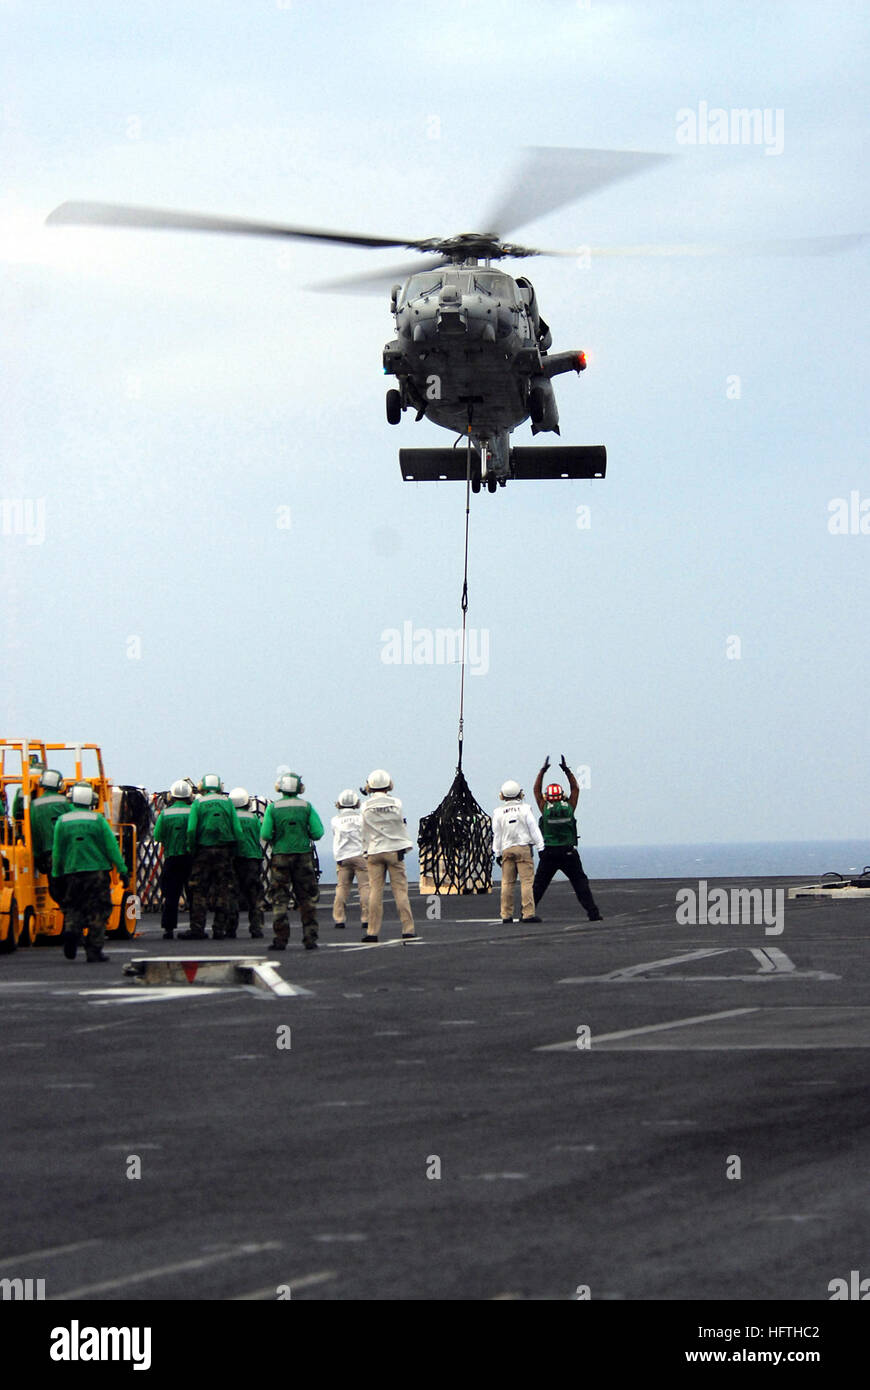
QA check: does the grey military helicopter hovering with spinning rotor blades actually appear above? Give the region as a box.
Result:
[46,147,866,492]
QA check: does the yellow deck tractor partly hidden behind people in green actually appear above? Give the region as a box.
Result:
[0,738,139,955]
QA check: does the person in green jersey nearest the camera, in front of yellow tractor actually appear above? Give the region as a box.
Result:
[51,783,129,960]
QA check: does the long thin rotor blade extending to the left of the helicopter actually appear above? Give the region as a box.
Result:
[46,203,428,249]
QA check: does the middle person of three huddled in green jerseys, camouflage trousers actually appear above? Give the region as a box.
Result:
[178,773,243,941]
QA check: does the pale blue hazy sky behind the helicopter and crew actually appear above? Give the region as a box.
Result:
[0,0,870,845]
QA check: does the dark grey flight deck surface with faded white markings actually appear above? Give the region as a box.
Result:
[0,880,870,1321]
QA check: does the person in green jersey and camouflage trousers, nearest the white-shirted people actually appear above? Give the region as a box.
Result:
[263,773,324,951]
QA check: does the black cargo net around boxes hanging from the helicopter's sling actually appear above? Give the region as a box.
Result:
[417,770,492,894]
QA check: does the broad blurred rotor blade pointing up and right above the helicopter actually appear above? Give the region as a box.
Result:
[482,146,675,236]
